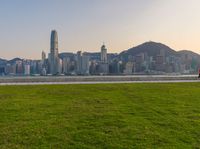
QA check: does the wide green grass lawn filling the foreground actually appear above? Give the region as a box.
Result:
[0,83,200,149]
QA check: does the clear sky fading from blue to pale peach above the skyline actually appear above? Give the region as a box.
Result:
[0,0,200,59]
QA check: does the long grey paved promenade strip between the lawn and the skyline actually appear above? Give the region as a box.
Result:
[0,75,200,85]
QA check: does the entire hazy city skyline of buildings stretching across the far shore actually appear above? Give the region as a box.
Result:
[0,30,199,76]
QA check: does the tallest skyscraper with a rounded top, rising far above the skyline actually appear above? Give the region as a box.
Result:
[49,30,60,75]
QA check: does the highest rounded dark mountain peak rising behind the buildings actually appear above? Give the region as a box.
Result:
[119,41,177,60]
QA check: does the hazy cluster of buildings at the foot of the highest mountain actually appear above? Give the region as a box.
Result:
[123,50,200,74]
